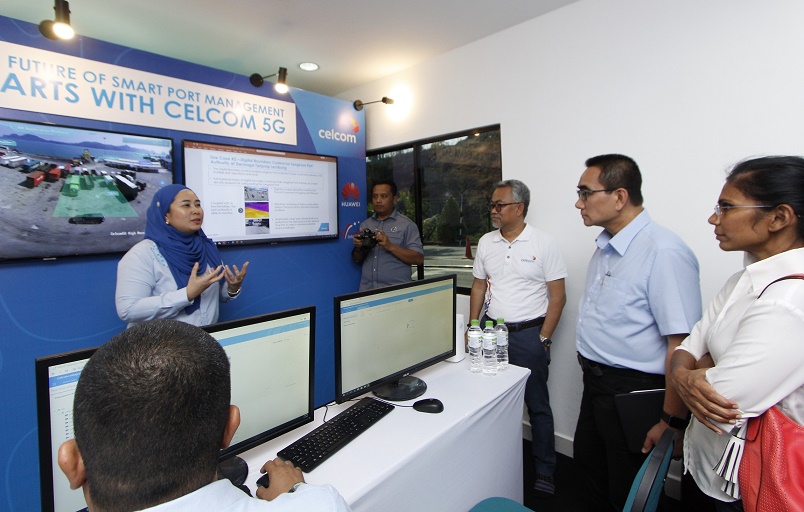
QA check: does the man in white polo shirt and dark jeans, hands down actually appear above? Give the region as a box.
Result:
[469,180,567,496]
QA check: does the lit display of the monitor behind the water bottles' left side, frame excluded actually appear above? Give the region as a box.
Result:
[341,283,455,390]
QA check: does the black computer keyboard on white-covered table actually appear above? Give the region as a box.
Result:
[277,397,394,473]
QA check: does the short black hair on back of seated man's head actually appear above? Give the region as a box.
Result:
[73,320,231,510]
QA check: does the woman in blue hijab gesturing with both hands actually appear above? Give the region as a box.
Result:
[115,185,248,326]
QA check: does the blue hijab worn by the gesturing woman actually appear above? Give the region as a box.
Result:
[145,185,221,314]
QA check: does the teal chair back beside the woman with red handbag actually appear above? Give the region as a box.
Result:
[623,428,676,512]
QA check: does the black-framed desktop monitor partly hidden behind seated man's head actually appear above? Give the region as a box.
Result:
[36,306,315,512]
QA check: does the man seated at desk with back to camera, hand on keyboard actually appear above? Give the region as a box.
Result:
[59,320,349,512]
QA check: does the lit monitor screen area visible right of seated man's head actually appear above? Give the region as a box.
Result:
[212,314,310,445]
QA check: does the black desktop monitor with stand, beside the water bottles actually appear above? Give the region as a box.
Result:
[335,274,457,403]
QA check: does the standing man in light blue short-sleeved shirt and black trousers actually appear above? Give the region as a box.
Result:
[573,154,701,511]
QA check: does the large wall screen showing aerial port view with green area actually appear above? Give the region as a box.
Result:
[0,119,173,260]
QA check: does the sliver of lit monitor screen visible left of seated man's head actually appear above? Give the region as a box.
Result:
[48,359,89,512]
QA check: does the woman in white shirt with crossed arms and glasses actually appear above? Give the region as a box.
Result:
[670,156,804,511]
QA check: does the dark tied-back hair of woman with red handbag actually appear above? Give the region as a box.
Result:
[726,156,804,238]
